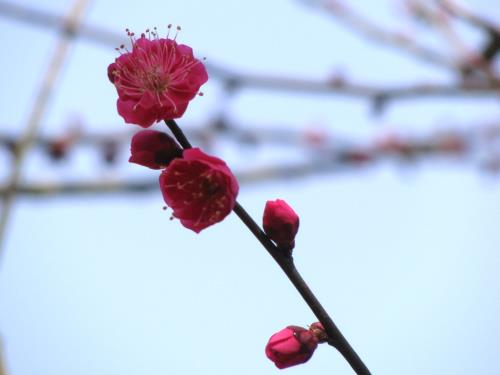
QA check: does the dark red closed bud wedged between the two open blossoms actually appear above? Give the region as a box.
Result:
[128,130,182,169]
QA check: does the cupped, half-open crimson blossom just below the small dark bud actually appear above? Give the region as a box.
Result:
[160,148,239,233]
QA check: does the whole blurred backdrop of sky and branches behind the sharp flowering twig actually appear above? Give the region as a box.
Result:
[0,0,500,375]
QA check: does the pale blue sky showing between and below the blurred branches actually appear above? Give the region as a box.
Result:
[0,0,500,375]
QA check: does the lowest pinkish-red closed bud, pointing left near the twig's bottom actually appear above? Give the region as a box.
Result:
[266,326,318,369]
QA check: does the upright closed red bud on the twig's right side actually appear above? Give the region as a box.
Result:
[263,199,299,251]
